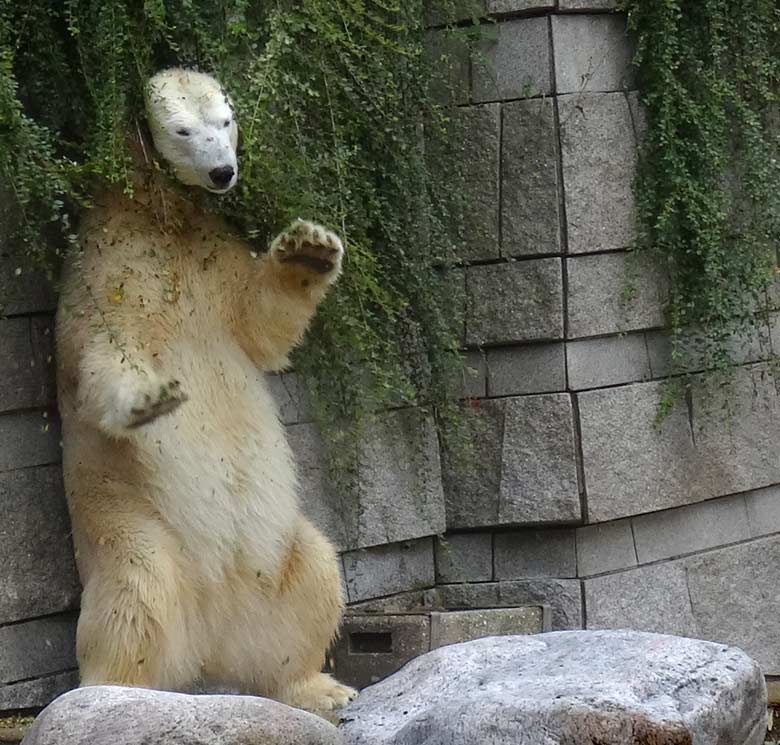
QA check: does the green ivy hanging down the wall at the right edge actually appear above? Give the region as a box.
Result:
[624,0,780,406]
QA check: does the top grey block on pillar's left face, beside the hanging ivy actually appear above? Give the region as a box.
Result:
[471,18,552,103]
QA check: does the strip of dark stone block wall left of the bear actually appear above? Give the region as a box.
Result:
[0,224,80,710]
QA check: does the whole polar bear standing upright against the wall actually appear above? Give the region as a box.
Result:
[57,69,355,711]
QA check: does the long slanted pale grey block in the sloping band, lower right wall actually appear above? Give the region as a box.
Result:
[632,494,750,564]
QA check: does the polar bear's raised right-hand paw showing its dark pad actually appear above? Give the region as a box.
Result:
[269,220,344,290]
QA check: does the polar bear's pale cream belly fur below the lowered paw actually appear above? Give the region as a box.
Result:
[132,336,298,581]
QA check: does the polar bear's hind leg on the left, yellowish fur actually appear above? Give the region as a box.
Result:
[77,508,199,690]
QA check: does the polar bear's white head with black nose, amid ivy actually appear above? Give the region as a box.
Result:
[146,68,238,194]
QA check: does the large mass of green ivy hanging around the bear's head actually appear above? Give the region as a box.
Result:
[0,0,472,470]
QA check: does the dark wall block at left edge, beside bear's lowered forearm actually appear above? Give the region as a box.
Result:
[0,318,55,411]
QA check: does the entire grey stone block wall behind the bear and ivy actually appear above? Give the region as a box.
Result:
[0,0,780,709]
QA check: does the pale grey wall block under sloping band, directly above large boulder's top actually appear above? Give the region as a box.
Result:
[584,562,700,636]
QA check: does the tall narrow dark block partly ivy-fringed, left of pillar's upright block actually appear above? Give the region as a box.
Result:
[450,104,501,261]
